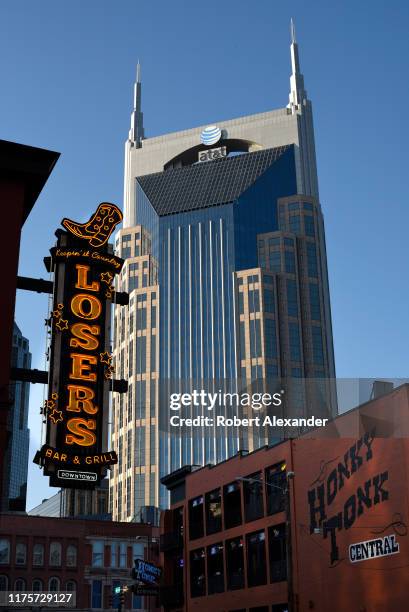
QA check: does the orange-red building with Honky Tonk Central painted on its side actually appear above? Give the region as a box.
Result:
[161,385,409,612]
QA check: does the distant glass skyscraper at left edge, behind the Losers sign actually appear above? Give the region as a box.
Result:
[1,323,31,512]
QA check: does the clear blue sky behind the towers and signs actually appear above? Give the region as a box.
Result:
[0,0,409,508]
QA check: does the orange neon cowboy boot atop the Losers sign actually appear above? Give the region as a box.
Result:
[61,202,122,247]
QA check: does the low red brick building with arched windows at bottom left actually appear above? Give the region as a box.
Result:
[0,514,159,610]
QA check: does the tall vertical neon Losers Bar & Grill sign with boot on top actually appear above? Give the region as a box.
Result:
[37,203,123,488]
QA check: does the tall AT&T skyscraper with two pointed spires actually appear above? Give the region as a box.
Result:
[111,24,336,520]
